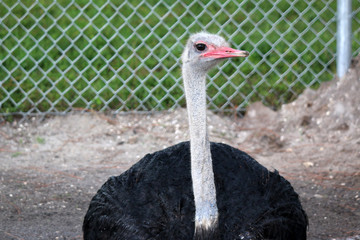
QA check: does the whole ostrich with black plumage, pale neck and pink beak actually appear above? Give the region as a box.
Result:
[83,32,308,240]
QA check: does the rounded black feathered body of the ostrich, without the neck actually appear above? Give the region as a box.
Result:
[83,142,307,240]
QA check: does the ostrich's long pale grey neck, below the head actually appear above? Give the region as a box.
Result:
[182,63,218,231]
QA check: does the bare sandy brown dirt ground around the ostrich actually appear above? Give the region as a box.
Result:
[0,56,360,240]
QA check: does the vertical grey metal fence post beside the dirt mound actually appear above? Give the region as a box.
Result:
[336,0,351,77]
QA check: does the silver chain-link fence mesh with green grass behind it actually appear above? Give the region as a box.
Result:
[0,0,360,118]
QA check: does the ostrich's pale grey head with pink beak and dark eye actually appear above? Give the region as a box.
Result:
[182,32,249,72]
